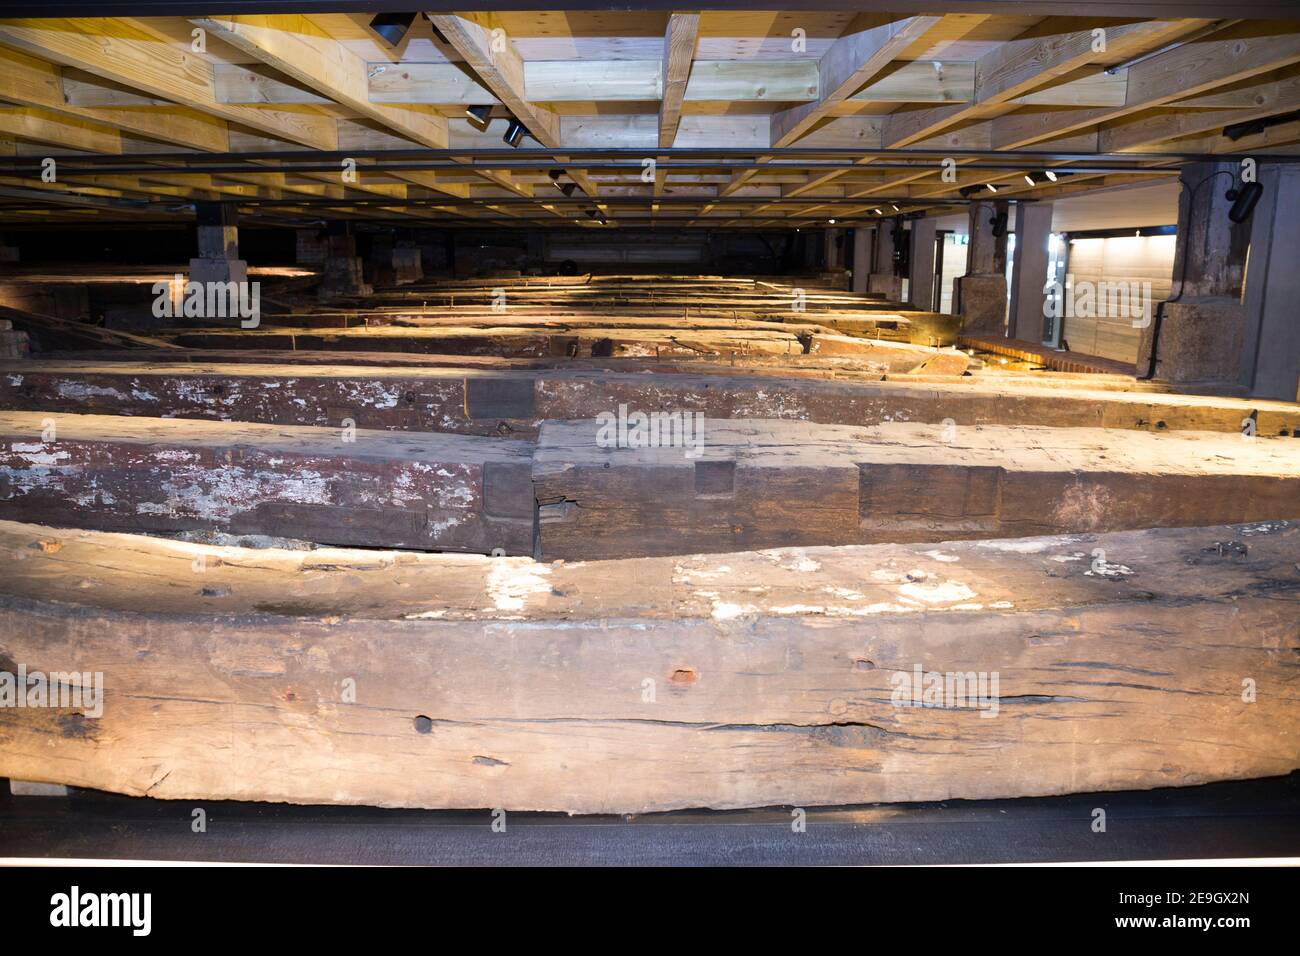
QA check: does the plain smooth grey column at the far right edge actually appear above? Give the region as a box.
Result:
[1237,165,1300,402]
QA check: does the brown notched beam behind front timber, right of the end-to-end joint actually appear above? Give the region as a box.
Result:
[533,410,1300,559]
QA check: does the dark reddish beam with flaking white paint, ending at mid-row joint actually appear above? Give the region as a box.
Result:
[0,410,533,554]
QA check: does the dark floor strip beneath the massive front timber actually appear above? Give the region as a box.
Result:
[0,773,1300,865]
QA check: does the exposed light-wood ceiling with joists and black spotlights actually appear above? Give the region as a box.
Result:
[0,4,1300,228]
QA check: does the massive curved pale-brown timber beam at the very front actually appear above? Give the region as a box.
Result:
[0,522,1300,813]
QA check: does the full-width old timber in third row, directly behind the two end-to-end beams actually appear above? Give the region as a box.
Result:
[10,360,1300,437]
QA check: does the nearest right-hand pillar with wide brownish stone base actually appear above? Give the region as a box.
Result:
[1138,161,1253,398]
